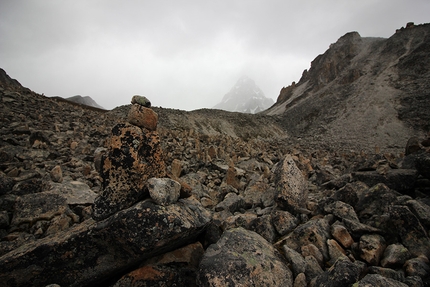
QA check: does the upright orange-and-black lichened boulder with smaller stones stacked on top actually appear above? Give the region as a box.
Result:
[93,96,166,220]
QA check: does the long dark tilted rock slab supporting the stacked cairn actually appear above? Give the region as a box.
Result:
[0,198,211,286]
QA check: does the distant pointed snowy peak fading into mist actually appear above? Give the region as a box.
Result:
[214,76,274,114]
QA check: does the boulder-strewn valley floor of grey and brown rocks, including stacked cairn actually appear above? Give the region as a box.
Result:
[0,85,430,287]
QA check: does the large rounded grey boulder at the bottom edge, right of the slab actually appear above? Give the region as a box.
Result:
[197,228,293,287]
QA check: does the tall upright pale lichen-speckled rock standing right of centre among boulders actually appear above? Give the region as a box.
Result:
[274,155,308,213]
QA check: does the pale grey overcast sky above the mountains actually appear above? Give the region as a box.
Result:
[0,0,430,110]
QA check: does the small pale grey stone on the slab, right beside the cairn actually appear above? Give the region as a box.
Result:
[147,178,181,206]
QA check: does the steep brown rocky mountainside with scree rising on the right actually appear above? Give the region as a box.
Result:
[264,24,430,153]
